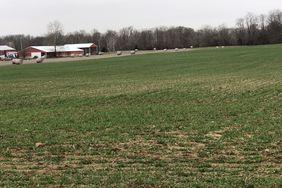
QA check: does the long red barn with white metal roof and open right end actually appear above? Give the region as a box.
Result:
[19,43,97,58]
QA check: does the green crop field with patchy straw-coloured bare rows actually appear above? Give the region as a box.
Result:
[0,45,282,188]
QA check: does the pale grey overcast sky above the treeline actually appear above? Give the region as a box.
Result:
[0,0,282,36]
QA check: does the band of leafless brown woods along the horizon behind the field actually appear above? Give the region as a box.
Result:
[0,10,282,52]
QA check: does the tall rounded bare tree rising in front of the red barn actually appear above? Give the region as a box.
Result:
[47,20,63,57]
